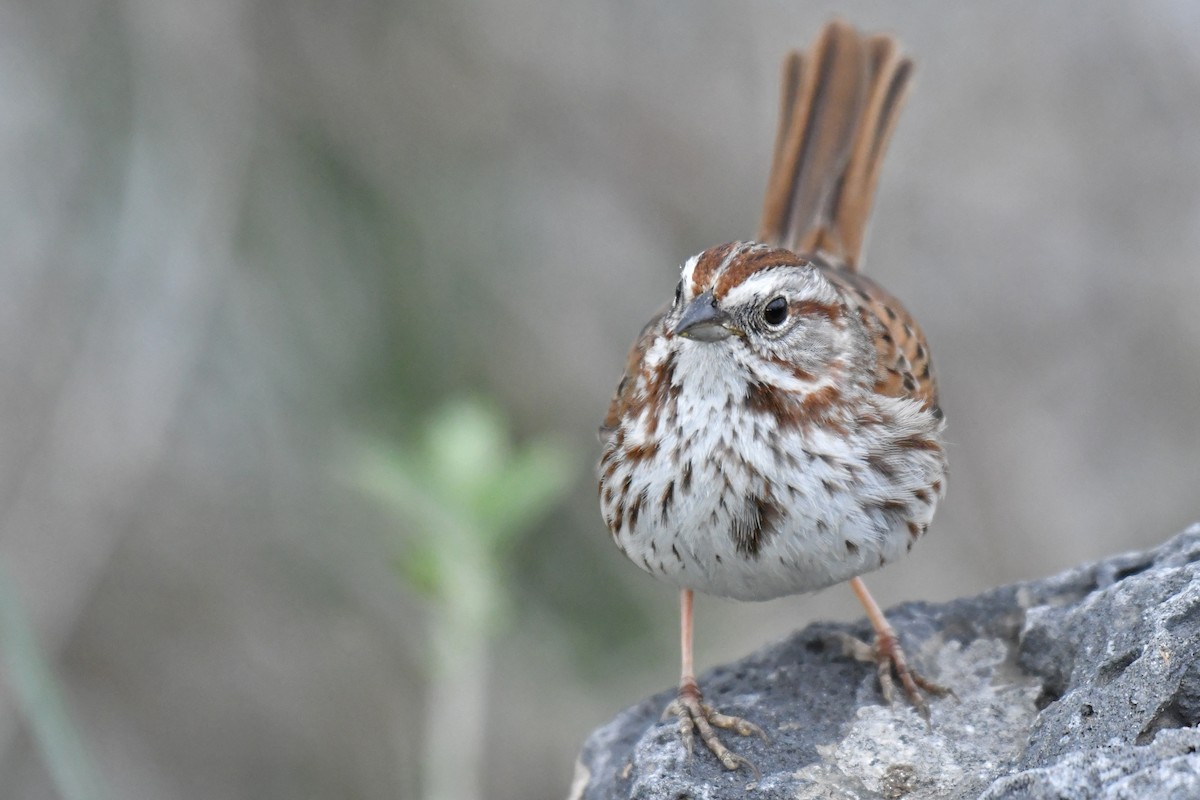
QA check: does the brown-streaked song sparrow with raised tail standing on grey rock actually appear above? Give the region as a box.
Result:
[600,22,946,769]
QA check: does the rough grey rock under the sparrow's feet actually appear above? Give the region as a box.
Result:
[571,524,1200,800]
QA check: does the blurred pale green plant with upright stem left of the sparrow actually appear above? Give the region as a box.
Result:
[358,399,574,800]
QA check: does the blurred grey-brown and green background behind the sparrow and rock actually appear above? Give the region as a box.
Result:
[0,0,1200,800]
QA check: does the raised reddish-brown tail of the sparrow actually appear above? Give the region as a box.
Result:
[758,20,912,270]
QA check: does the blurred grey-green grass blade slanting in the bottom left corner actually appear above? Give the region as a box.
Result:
[0,565,106,800]
